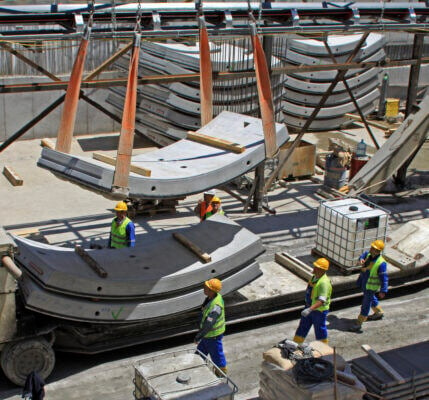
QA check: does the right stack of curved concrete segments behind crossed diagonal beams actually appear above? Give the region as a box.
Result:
[274,33,385,131]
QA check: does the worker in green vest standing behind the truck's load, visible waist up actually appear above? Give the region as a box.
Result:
[108,201,136,249]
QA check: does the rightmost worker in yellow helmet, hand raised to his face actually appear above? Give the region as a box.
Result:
[350,240,388,333]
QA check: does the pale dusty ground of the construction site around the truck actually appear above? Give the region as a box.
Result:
[0,129,429,400]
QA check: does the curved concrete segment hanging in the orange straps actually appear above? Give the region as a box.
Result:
[38,111,289,199]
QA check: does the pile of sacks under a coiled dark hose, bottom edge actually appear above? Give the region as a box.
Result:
[259,341,365,400]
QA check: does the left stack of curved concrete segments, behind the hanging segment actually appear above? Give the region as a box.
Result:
[106,41,282,146]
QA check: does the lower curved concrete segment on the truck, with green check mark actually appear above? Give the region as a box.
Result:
[20,262,262,323]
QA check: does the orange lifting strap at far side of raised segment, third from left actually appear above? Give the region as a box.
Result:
[200,17,213,126]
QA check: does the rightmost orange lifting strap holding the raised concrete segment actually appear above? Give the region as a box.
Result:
[251,23,277,158]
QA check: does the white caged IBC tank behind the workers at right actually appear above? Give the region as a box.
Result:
[315,199,389,268]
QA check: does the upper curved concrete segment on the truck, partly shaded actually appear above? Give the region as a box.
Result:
[14,215,264,299]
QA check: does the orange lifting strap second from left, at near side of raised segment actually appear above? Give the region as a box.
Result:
[112,33,141,197]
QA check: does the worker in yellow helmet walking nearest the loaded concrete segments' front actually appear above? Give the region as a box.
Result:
[195,278,227,373]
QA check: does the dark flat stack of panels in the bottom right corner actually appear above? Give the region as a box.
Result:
[352,341,429,400]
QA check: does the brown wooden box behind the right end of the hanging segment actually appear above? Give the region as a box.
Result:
[279,140,316,178]
